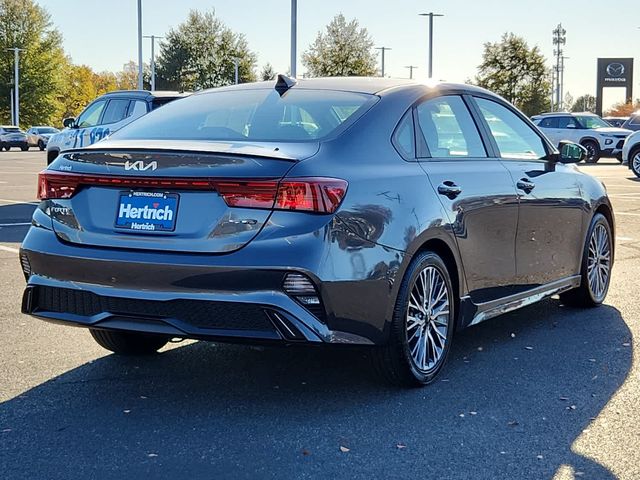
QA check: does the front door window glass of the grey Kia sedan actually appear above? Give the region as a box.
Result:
[476,98,547,160]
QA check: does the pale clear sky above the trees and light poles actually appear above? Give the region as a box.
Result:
[39,0,640,109]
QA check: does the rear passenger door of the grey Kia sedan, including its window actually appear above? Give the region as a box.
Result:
[414,95,518,304]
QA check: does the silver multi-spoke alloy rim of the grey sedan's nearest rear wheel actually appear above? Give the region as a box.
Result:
[406,266,451,373]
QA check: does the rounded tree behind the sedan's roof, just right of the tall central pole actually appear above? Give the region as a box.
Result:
[302,14,377,77]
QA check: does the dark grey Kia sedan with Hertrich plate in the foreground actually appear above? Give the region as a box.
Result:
[20,75,615,385]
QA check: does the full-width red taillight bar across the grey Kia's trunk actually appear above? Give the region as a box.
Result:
[38,170,348,213]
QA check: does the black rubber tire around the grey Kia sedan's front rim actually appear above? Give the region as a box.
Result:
[560,213,613,308]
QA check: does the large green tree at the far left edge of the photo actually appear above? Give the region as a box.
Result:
[0,0,66,127]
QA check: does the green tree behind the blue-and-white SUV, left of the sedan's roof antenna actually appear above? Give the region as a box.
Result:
[156,10,257,91]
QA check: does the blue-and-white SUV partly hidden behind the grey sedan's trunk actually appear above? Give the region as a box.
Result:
[47,90,188,164]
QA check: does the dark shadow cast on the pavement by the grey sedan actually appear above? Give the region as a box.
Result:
[0,300,632,479]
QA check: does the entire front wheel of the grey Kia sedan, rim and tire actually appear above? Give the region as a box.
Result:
[560,213,613,307]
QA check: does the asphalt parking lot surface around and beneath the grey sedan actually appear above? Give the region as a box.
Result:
[0,151,640,479]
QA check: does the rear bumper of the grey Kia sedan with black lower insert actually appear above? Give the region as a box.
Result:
[21,221,390,345]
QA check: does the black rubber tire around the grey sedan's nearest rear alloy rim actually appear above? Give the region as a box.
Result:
[373,252,457,387]
